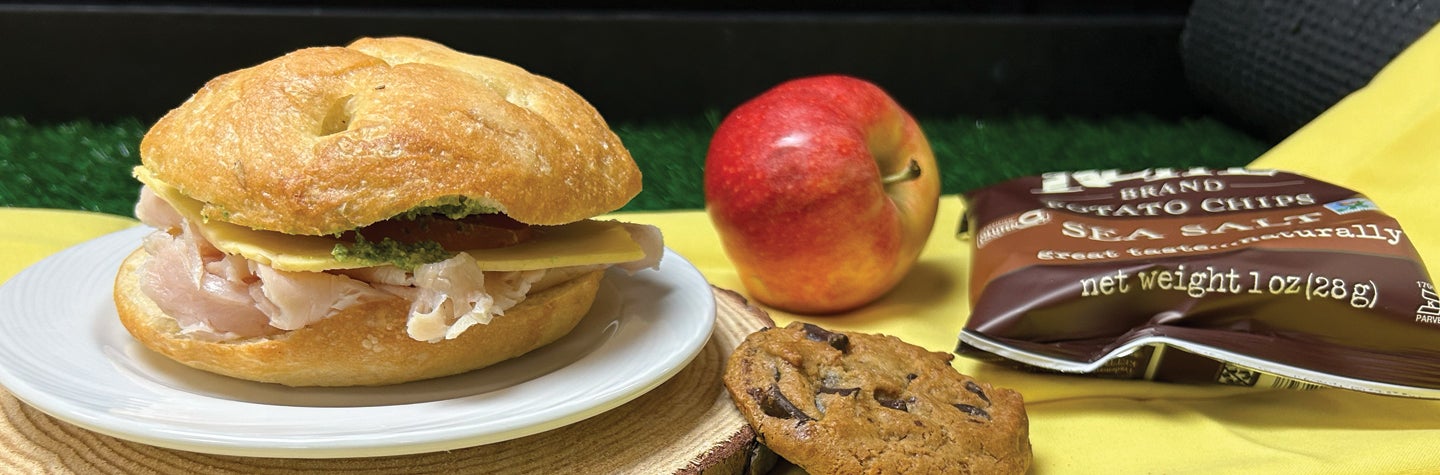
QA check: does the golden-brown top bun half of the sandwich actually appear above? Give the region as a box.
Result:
[140,37,641,235]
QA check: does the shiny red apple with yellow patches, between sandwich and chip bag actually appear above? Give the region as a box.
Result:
[704,75,940,314]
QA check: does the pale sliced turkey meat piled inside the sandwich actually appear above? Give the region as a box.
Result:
[126,187,664,341]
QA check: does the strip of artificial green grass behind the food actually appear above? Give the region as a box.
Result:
[0,112,1270,216]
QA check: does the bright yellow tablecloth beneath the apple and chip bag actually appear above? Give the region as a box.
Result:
[8,25,1440,474]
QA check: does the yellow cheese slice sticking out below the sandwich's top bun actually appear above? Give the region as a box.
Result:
[135,166,645,272]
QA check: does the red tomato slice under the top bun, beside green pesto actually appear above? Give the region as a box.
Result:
[340,214,530,250]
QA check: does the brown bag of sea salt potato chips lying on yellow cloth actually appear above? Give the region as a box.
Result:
[956,168,1440,397]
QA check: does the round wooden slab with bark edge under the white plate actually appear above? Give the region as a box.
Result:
[0,288,775,475]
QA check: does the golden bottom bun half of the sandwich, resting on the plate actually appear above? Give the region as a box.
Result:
[115,249,603,386]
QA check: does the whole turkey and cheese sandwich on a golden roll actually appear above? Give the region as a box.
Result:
[114,37,664,386]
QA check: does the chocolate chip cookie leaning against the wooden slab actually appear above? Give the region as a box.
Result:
[724,322,1030,475]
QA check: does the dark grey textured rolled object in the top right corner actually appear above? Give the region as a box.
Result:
[1181,0,1440,140]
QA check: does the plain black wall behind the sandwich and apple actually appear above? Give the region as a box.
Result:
[0,0,1204,121]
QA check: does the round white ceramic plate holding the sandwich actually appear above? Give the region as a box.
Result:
[0,227,716,458]
